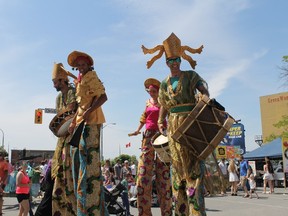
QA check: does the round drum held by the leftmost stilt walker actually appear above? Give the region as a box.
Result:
[49,109,75,137]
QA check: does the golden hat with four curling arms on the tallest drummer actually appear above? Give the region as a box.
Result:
[142,33,204,69]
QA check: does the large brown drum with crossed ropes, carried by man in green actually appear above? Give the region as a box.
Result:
[172,95,235,160]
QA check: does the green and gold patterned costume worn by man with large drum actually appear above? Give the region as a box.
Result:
[159,71,206,215]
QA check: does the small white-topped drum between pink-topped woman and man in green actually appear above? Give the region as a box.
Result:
[151,133,171,164]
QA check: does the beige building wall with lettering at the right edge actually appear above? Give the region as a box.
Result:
[260,92,288,143]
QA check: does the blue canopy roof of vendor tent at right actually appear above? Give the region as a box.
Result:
[244,138,282,160]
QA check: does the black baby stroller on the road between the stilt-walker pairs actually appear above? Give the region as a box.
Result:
[104,183,126,216]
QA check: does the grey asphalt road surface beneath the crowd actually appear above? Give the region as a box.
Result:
[3,188,288,216]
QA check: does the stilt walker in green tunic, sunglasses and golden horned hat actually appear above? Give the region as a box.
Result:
[142,33,209,216]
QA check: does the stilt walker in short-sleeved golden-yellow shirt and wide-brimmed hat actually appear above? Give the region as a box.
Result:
[68,51,108,216]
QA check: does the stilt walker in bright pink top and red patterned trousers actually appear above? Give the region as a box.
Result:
[129,78,172,216]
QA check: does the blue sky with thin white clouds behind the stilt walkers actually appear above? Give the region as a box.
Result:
[0,0,288,158]
